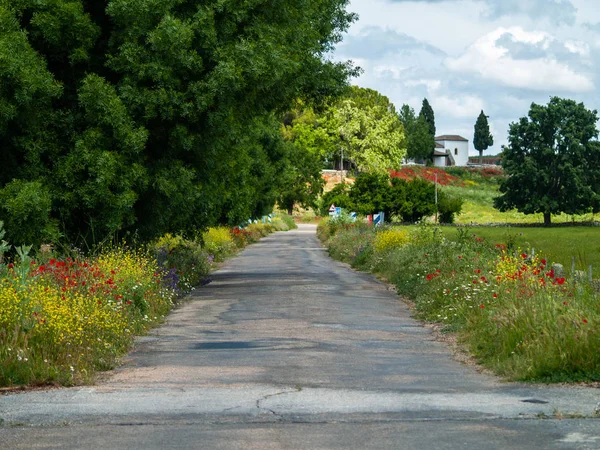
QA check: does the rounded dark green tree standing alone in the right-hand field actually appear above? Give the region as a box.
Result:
[494,97,600,225]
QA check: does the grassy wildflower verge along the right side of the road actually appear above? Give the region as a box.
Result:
[319,221,600,381]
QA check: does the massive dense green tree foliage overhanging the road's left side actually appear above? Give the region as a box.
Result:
[0,0,355,243]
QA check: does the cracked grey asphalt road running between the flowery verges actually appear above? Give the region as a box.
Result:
[0,225,600,449]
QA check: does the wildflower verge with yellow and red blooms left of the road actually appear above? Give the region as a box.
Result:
[0,217,296,386]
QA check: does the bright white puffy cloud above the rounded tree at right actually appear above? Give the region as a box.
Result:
[446,27,594,92]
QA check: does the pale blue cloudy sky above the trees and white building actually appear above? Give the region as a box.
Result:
[335,0,600,155]
